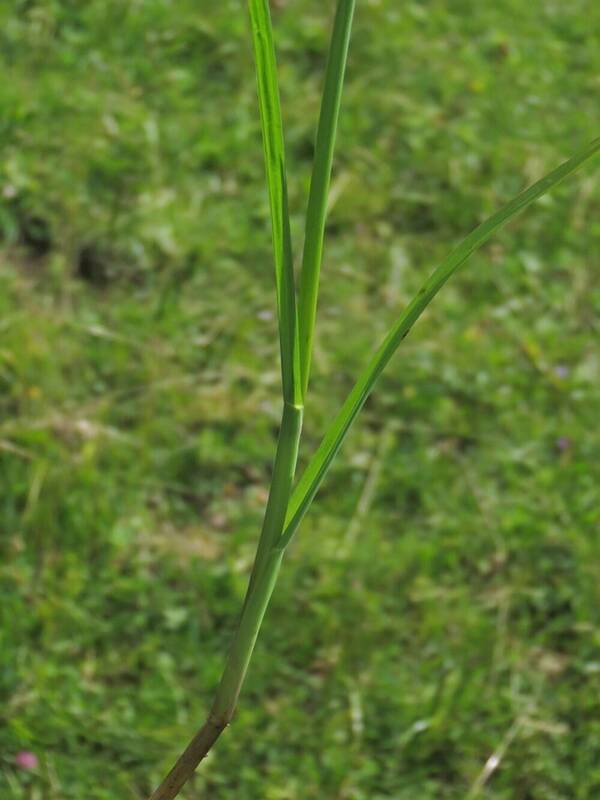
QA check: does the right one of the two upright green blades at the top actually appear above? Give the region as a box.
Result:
[298,0,355,396]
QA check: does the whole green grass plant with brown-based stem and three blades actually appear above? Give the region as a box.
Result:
[150,0,600,800]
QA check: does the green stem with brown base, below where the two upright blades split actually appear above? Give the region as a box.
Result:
[150,403,303,800]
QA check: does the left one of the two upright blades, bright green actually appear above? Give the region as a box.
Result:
[248,0,301,404]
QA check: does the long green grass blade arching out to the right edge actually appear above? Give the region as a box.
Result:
[278,139,600,549]
